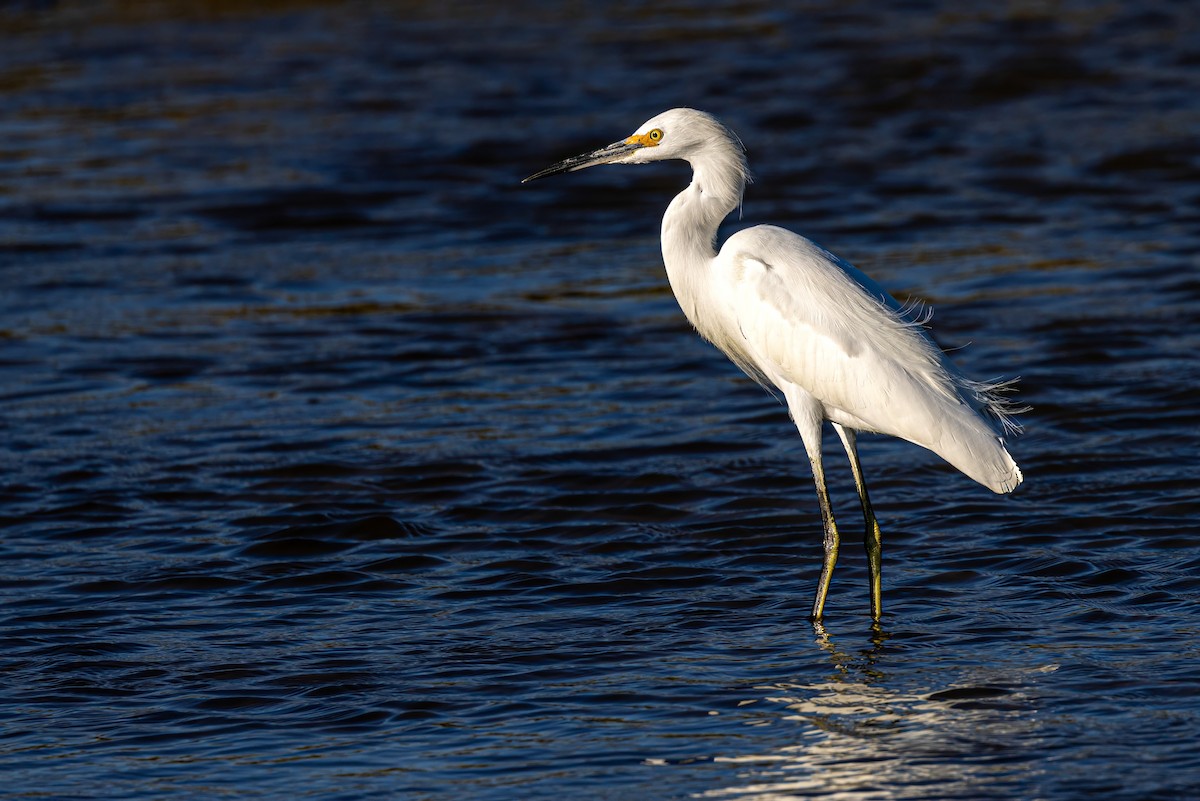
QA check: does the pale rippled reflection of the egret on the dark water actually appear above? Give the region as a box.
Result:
[702,624,1054,801]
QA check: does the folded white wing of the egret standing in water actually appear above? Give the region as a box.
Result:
[714,225,1020,492]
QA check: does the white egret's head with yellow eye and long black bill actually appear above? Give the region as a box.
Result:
[522,108,749,183]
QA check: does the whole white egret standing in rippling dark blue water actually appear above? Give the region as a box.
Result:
[522,108,1024,621]
